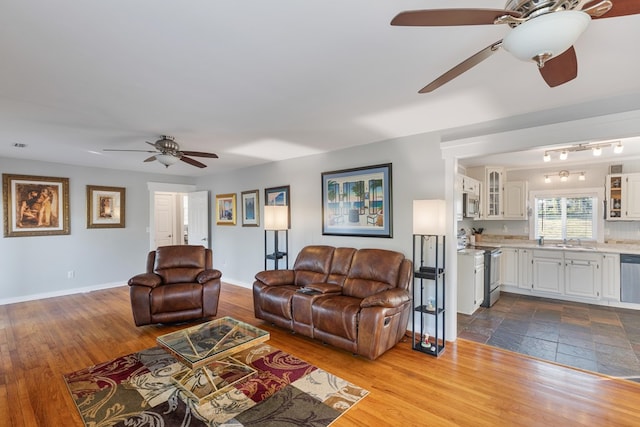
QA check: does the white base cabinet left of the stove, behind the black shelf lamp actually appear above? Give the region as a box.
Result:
[458,249,484,315]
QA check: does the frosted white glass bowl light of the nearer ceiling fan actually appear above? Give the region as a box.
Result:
[502,10,591,67]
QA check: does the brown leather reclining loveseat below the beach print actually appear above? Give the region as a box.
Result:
[253,246,413,360]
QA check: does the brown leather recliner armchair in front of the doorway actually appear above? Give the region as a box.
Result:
[129,246,222,326]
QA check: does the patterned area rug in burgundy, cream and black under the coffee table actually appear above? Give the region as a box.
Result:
[64,344,368,427]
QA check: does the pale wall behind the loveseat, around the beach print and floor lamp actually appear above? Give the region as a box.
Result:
[197,135,445,287]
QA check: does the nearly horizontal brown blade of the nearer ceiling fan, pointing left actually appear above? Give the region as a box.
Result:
[391,9,522,27]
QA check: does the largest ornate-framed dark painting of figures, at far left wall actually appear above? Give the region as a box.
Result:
[2,174,70,237]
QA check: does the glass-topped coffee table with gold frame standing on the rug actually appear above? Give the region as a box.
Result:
[156,317,269,404]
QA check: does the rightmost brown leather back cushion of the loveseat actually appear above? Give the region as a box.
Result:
[342,249,404,298]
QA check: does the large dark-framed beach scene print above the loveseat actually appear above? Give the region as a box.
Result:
[322,163,393,237]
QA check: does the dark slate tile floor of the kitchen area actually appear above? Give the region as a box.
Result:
[458,292,640,381]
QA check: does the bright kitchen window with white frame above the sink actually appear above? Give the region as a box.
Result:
[531,189,603,241]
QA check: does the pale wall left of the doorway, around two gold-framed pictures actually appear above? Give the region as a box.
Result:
[0,158,194,304]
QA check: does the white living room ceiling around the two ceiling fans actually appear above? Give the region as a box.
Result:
[0,0,640,176]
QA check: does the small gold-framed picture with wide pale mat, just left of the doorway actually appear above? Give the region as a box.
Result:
[87,185,126,228]
